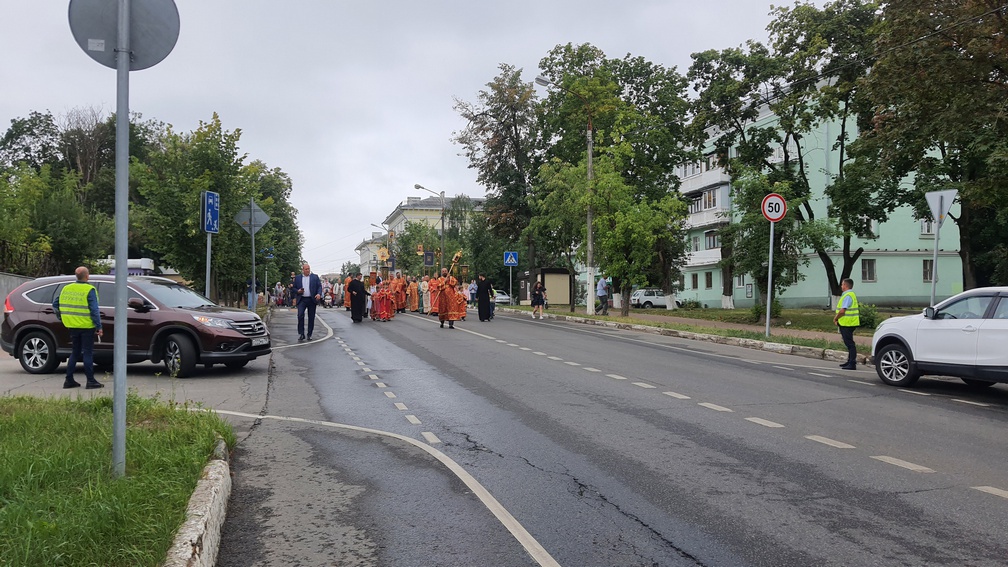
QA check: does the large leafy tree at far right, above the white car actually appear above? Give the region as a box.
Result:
[864,0,1008,289]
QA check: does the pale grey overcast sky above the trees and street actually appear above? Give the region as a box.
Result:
[0,0,788,273]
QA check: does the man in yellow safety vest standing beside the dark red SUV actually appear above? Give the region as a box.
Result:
[52,265,105,389]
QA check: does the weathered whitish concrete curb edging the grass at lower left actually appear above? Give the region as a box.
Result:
[161,439,231,567]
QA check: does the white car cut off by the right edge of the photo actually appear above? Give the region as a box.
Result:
[872,287,1008,387]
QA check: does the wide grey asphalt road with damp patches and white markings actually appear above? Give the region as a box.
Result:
[7,310,1008,566]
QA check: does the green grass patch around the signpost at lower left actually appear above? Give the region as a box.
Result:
[0,392,235,567]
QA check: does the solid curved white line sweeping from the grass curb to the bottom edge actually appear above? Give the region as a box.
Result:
[215,405,559,567]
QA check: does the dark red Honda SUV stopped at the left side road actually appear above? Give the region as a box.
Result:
[0,275,272,377]
